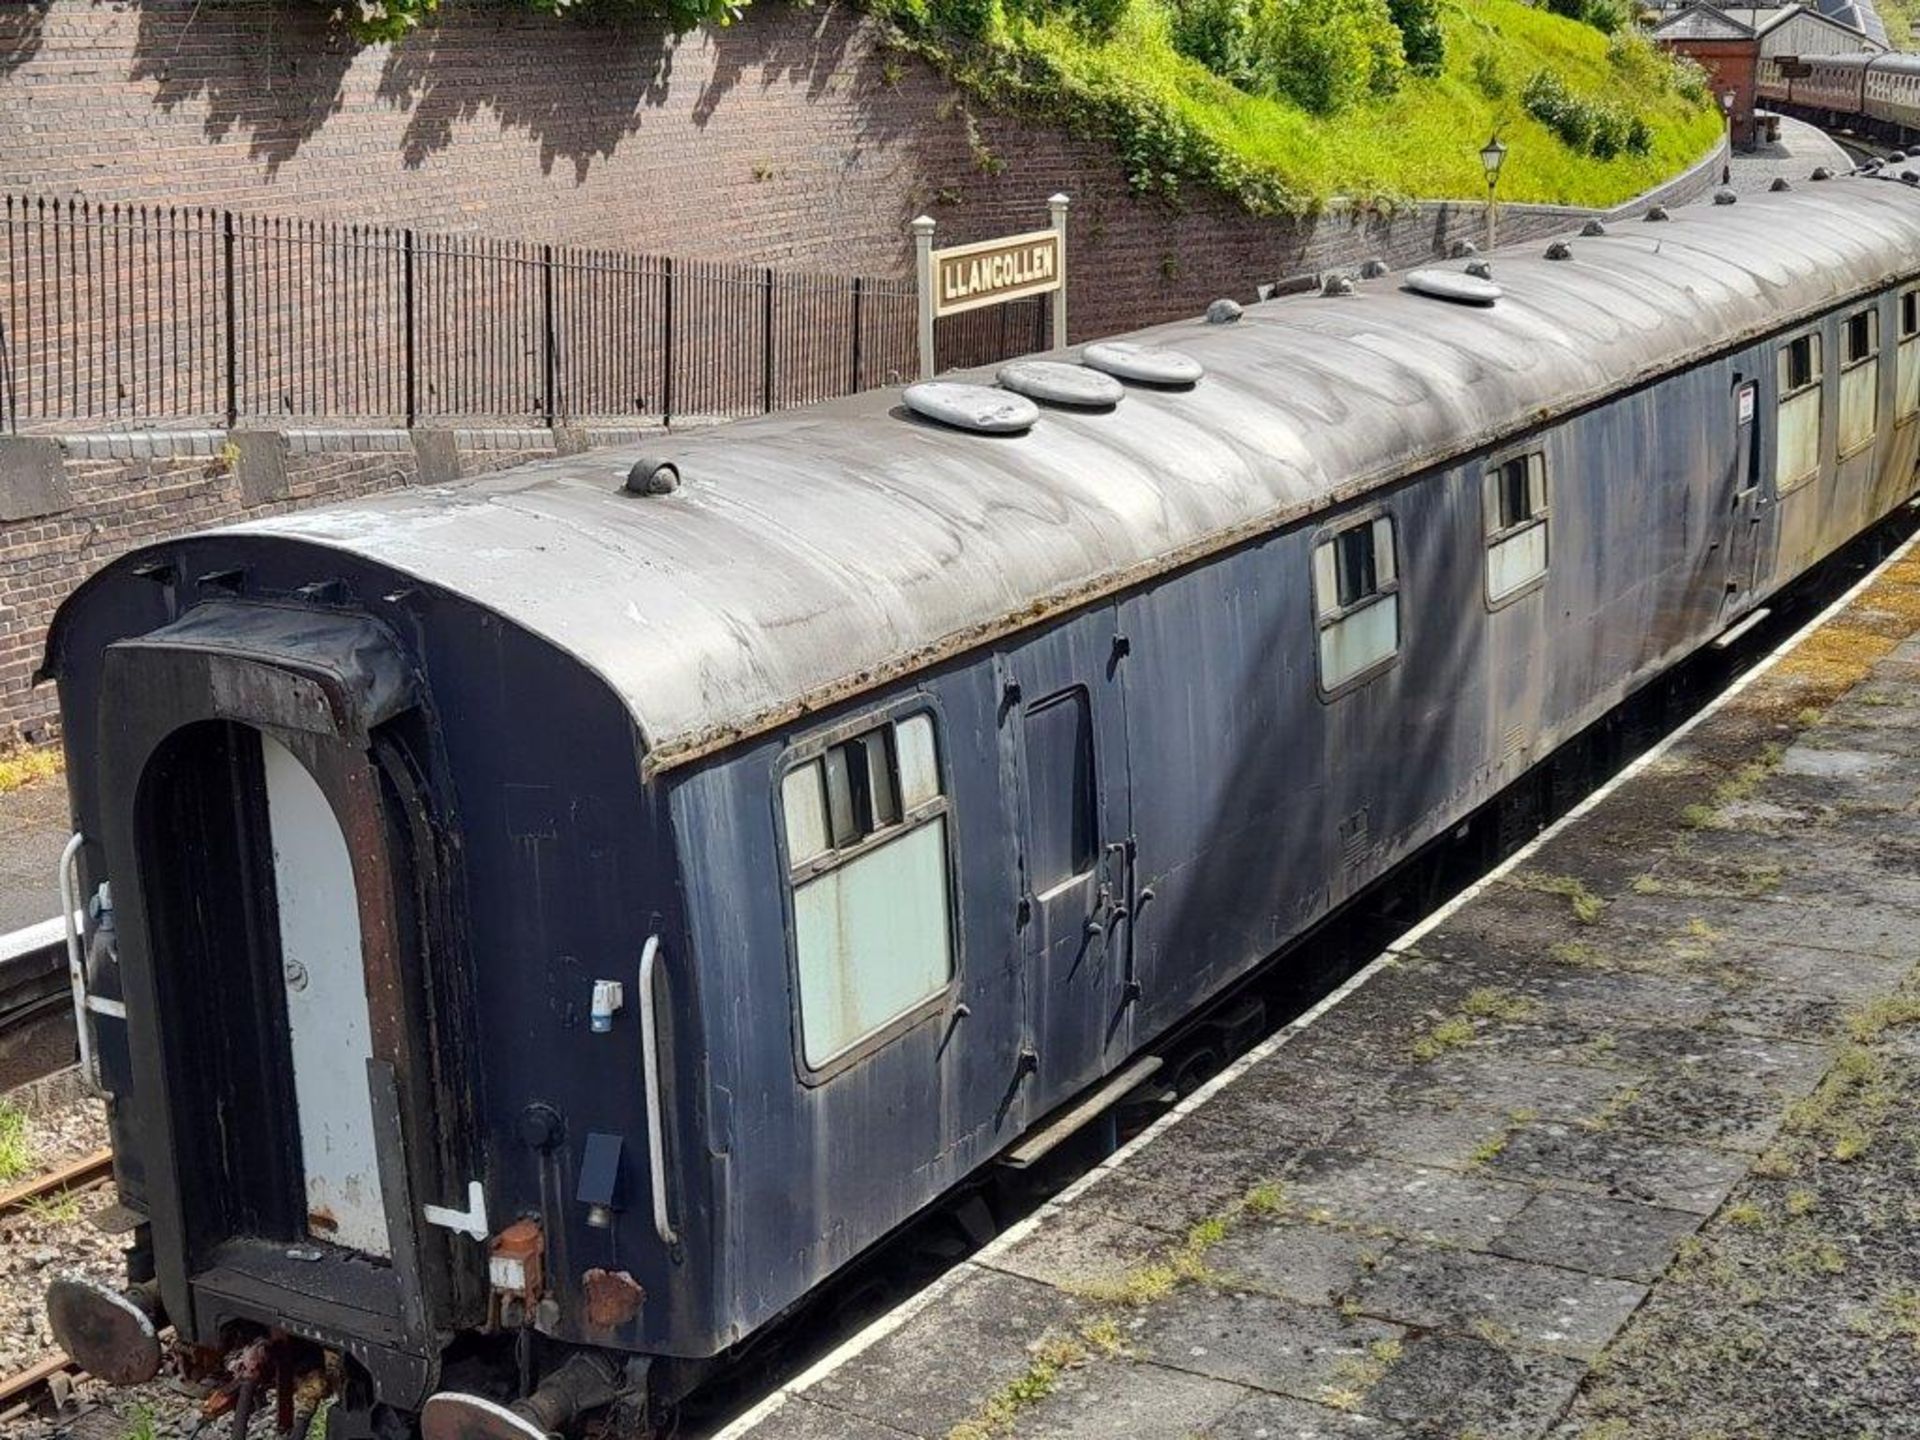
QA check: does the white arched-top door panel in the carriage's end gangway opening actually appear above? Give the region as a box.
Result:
[259,735,394,1256]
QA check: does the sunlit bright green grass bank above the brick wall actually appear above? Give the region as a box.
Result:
[870,0,1720,213]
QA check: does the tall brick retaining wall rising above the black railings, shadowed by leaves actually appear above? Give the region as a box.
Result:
[0,0,1728,347]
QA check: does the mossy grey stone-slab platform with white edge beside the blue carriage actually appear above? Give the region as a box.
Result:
[724,551,1920,1440]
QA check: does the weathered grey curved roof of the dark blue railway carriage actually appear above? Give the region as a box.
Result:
[210,179,1920,768]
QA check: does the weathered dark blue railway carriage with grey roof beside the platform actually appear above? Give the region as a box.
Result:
[33,177,1920,1438]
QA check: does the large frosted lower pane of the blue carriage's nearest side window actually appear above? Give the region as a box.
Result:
[793,816,952,1066]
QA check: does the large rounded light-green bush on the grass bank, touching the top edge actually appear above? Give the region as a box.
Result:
[1254,0,1407,115]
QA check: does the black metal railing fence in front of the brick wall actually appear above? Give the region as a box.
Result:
[0,196,1046,430]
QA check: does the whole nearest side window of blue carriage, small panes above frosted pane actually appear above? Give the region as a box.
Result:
[780,714,952,1069]
